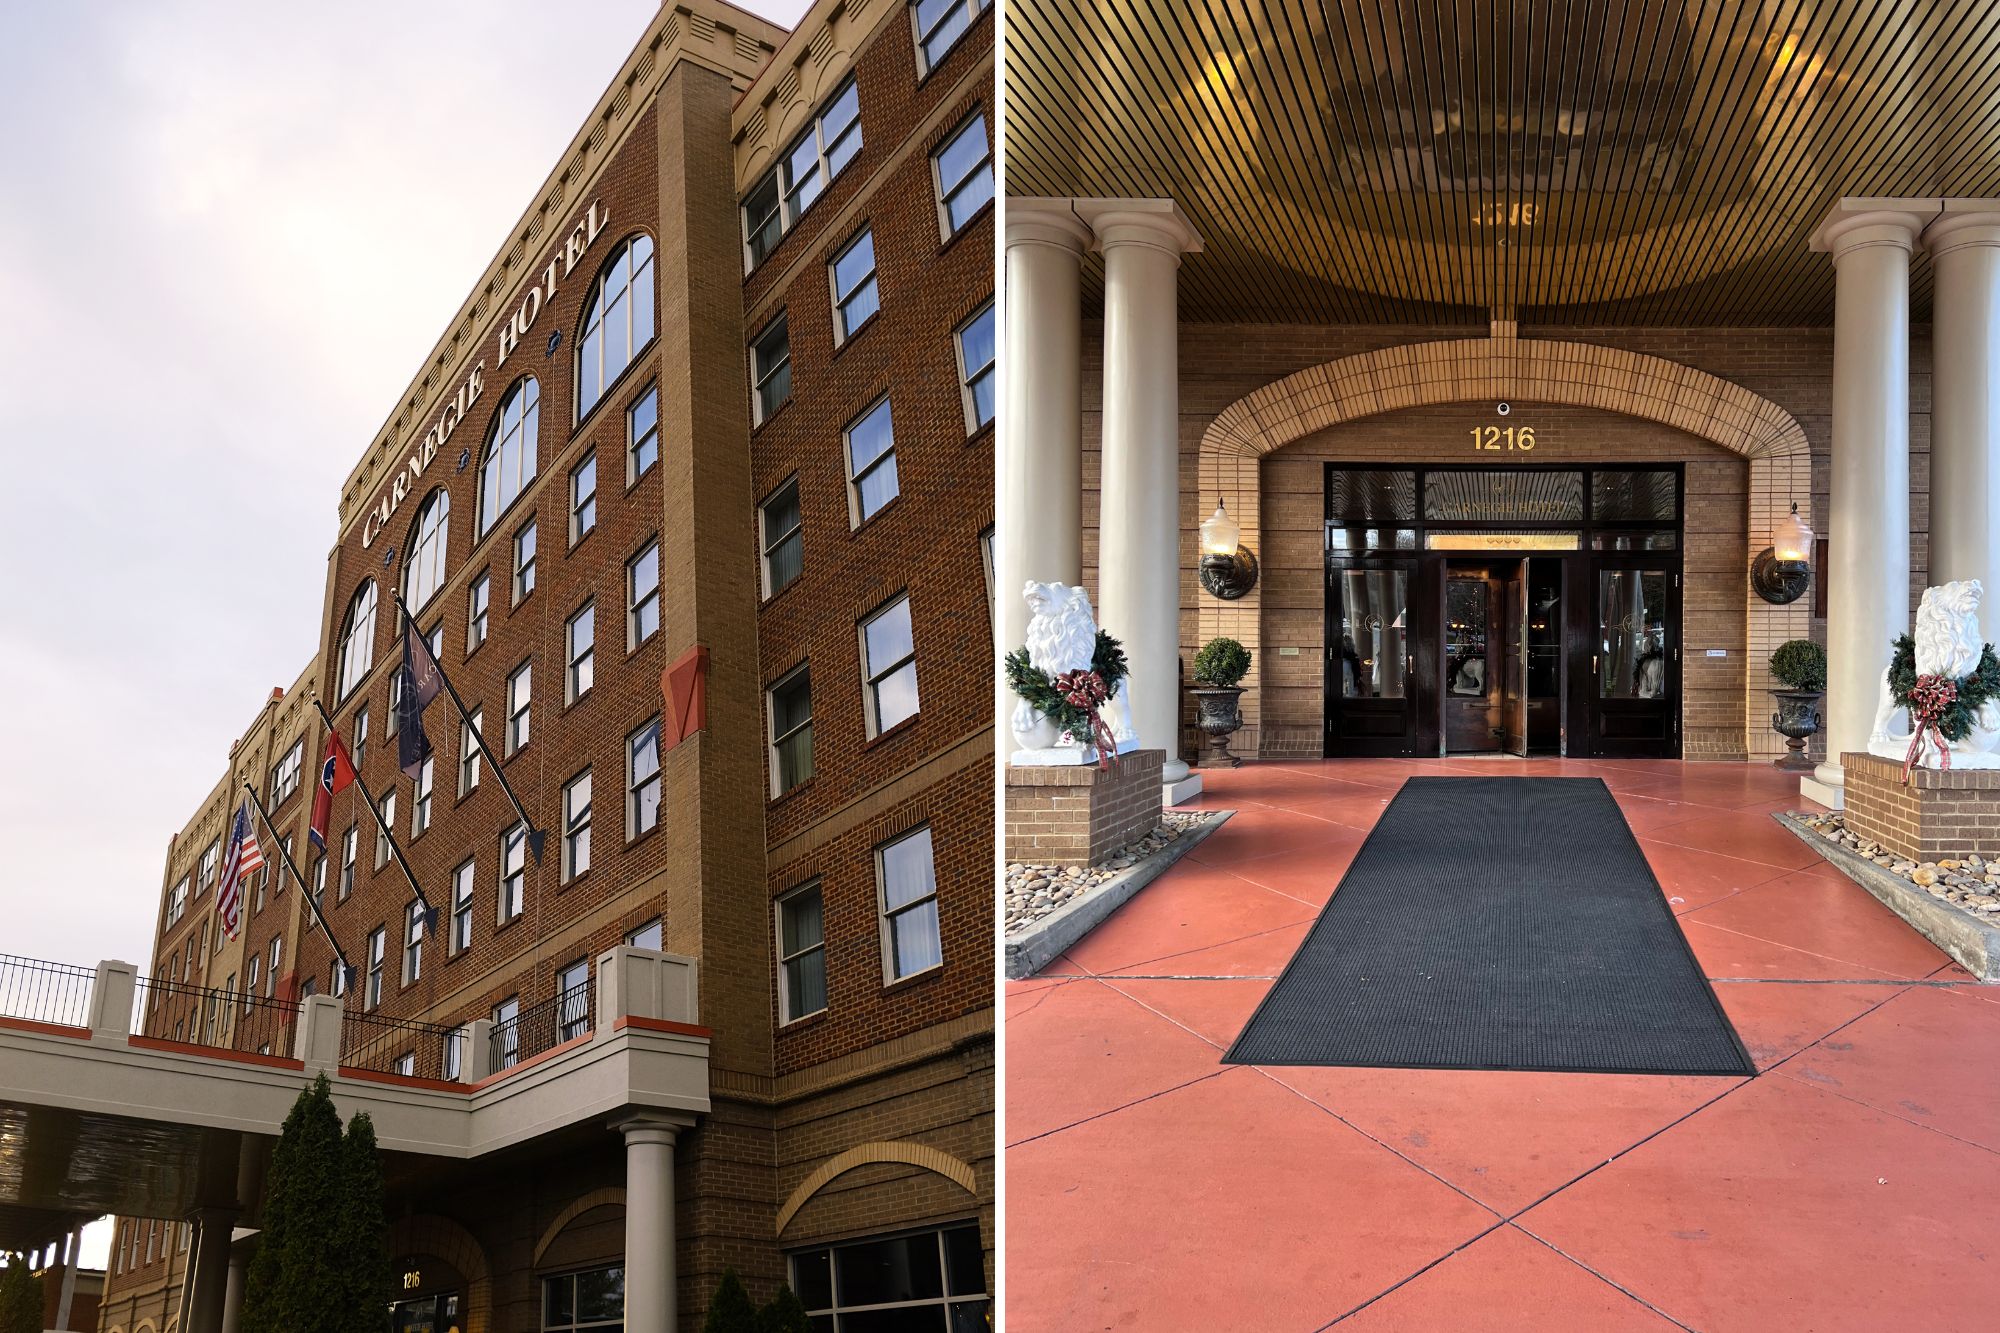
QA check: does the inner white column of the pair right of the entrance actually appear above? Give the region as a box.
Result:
[1802,198,1930,805]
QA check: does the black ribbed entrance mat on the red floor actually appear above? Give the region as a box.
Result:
[1224,779,1756,1077]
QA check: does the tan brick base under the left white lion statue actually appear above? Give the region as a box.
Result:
[1006,751,1166,865]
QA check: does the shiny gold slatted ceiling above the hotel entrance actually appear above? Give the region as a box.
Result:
[1004,0,2000,326]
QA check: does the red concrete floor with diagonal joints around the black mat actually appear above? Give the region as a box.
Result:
[1006,761,2000,1333]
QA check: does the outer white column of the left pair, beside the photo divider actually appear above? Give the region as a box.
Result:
[994,198,1090,761]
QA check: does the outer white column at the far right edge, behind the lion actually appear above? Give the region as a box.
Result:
[1924,198,2000,600]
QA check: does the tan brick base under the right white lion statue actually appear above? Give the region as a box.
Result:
[1840,755,2000,863]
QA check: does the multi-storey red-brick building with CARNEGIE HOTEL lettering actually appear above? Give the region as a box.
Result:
[100,0,994,1333]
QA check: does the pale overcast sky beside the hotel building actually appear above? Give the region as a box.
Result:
[0,0,806,1263]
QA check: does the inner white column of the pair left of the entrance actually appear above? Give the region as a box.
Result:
[1078,200,1200,787]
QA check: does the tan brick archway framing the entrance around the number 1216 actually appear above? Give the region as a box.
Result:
[1194,338,1812,759]
